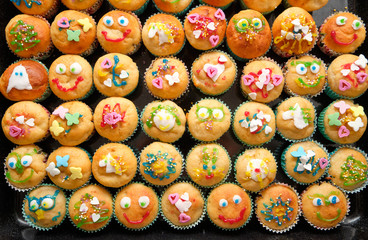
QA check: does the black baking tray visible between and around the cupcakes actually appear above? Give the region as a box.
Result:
[0,0,368,240]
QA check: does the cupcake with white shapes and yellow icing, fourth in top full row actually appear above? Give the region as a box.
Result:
[142,13,185,56]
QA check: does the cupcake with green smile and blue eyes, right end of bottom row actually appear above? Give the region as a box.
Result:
[301,182,350,230]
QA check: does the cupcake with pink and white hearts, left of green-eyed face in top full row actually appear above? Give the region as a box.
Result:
[184,6,226,50]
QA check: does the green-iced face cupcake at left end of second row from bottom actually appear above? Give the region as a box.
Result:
[4,145,47,191]
